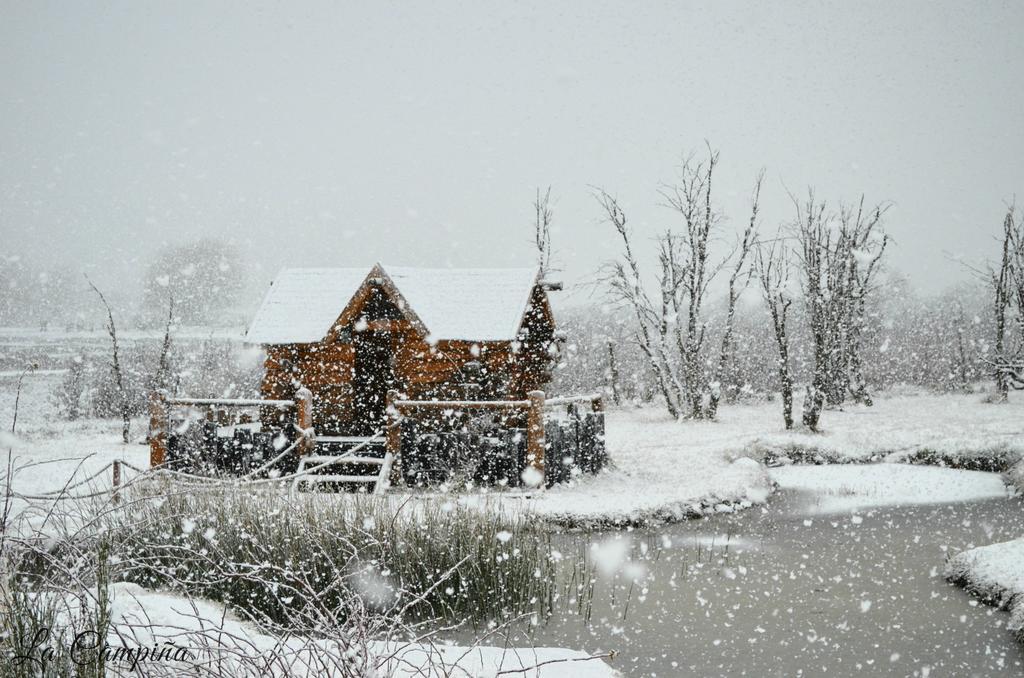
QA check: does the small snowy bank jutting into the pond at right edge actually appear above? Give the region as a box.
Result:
[945,539,1024,642]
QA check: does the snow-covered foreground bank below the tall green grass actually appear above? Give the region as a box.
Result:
[36,583,618,678]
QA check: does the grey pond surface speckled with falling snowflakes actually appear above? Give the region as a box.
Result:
[491,476,1024,676]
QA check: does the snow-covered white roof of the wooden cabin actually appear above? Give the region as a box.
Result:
[246,265,538,344]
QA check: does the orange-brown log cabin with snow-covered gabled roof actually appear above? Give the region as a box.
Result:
[246,263,560,436]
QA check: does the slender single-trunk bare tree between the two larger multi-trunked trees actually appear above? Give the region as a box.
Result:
[755,233,794,429]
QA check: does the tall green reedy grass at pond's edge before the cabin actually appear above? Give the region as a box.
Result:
[109,488,573,633]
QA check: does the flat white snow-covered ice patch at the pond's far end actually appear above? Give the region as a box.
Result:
[771,463,1013,513]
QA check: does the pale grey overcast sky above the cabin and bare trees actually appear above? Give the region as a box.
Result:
[0,0,1024,307]
